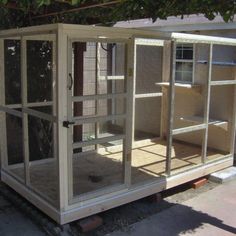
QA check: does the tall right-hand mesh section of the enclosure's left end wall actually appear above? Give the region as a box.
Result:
[24,37,58,204]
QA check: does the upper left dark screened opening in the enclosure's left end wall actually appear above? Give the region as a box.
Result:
[4,39,21,104]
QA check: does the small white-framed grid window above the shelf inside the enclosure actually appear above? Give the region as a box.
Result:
[175,43,194,83]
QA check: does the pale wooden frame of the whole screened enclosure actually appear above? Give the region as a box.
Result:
[0,24,236,224]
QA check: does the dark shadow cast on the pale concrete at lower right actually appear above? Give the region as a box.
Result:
[121,201,236,236]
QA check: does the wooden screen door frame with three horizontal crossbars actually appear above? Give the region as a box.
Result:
[68,35,129,204]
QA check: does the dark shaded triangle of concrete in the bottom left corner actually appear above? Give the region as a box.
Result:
[0,196,46,236]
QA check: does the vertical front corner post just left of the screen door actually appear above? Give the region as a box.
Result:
[56,24,69,211]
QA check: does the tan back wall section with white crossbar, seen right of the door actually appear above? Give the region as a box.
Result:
[134,39,163,140]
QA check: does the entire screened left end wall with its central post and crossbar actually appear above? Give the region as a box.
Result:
[1,35,58,205]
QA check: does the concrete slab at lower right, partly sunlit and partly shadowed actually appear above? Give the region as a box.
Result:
[108,180,236,236]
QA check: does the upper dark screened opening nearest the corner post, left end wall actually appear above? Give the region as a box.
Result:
[27,40,53,102]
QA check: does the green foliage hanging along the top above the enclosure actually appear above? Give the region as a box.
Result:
[0,0,236,29]
